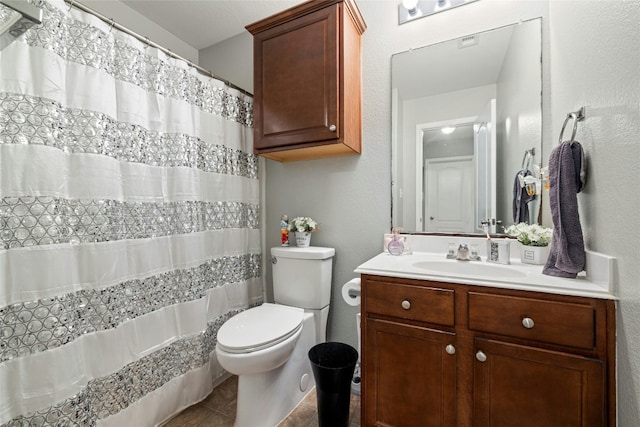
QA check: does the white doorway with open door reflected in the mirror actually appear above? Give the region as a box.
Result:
[416,99,501,233]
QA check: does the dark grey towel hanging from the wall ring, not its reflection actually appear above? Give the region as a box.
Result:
[542,141,586,279]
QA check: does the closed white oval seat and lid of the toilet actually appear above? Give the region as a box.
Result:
[217,303,304,353]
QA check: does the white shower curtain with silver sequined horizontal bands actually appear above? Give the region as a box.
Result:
[0,0,263,427]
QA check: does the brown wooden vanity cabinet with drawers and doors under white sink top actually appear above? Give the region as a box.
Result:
[361,274,615,427]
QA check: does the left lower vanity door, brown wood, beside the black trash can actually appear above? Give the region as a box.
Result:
[363,318,456,427]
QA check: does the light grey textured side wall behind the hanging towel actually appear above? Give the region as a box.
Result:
[546,1,640,427]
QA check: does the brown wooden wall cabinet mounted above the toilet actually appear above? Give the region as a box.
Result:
[246,0,366,161]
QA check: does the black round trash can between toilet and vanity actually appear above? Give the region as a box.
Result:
[309,342,358,427]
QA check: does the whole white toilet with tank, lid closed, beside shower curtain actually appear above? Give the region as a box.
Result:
[216,246,335,427]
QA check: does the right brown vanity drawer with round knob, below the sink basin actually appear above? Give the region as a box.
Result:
[469,292,595,349]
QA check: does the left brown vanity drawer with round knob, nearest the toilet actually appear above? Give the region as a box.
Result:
[365,281,455,326]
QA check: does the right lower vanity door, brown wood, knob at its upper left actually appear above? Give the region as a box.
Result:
[474,339,606,427]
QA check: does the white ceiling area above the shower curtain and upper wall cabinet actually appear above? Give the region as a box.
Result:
[121,0,303,50]
